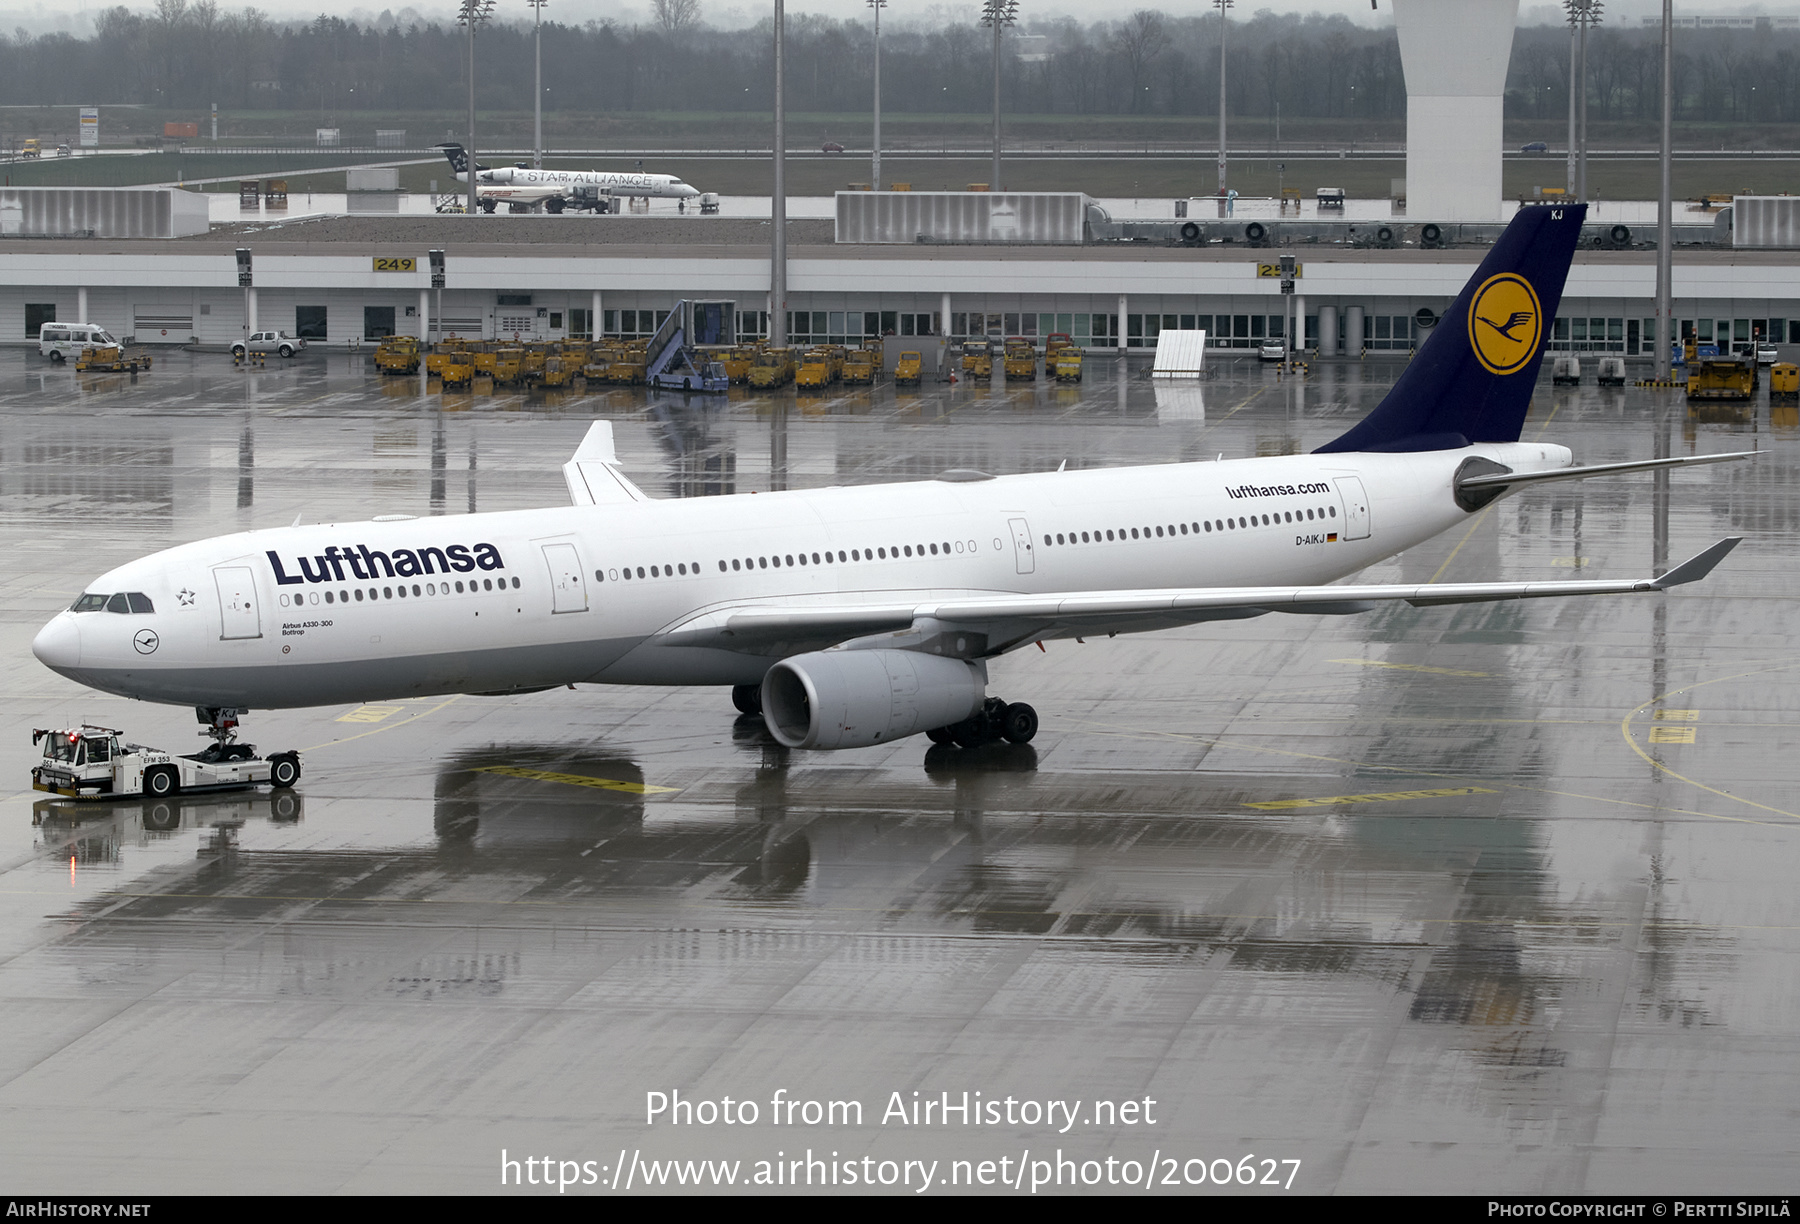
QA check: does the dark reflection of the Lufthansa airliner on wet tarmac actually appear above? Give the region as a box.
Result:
[66,745,1733,1044]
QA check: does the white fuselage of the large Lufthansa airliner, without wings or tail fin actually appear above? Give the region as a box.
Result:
[34,443,1570,709]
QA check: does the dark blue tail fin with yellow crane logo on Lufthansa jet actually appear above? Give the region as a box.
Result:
[1318,203,1588,454]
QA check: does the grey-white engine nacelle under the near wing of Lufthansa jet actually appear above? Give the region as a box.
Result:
[763,650,988,749]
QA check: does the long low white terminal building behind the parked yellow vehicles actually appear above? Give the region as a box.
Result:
[0,226,1800,356]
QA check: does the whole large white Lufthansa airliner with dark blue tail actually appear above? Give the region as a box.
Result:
[32,205,1739,749]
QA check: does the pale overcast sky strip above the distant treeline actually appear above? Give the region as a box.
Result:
[0,0,1800,36]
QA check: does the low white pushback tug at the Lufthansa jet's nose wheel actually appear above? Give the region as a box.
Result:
[31,709,301,799]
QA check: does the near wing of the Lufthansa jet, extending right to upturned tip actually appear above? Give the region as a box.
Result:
[659,536,1742,655]
